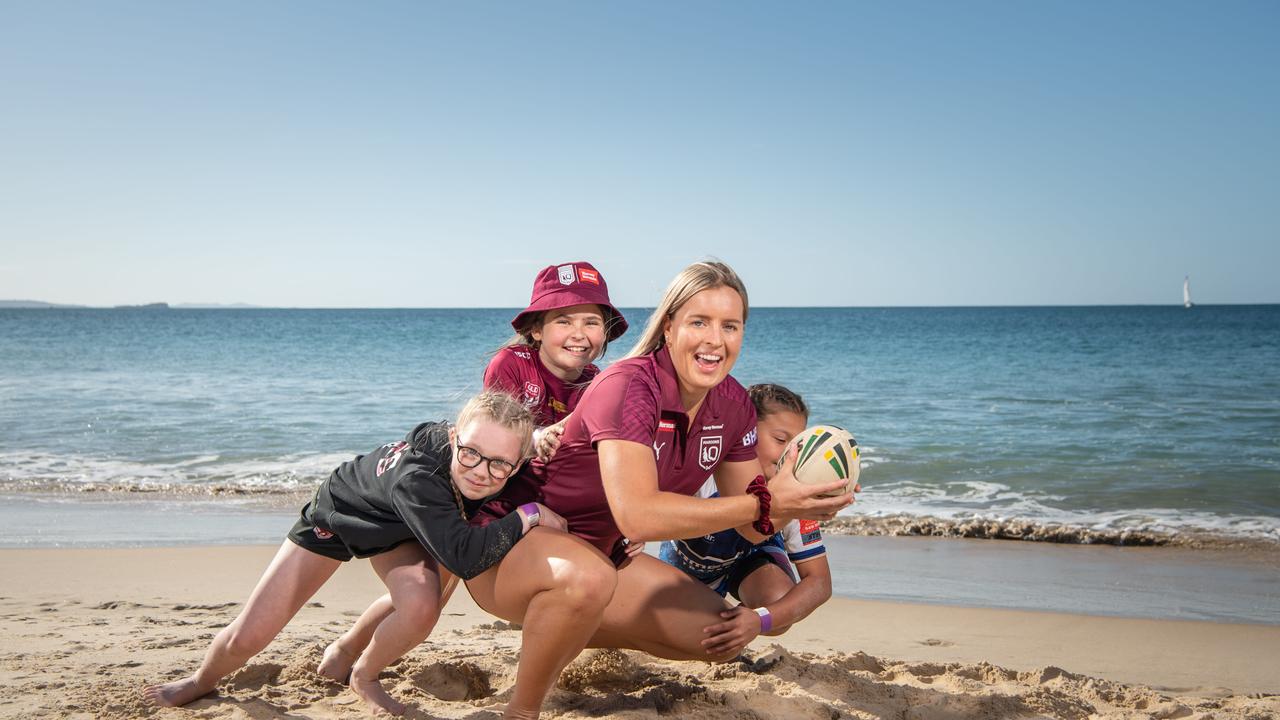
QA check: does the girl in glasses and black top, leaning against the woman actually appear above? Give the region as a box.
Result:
[143,392,564,715]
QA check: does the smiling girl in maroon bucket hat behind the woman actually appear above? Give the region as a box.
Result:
[484,261,627,459]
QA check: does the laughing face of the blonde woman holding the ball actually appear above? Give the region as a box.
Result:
[663,286,745,410]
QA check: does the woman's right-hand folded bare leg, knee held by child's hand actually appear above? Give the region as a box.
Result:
[589,555,739,662]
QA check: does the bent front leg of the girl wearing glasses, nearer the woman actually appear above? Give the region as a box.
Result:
[351,542,442,715]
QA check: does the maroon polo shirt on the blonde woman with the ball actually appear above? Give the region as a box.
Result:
[480,348,756,565]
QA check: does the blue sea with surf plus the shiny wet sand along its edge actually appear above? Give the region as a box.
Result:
[0,305,1280,623]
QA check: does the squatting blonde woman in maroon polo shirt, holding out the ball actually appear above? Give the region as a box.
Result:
[467,263,852,717]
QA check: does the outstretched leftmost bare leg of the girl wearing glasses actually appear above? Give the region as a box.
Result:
[142,541,342,707]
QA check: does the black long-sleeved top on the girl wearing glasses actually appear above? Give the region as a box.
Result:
[310,423,524,580]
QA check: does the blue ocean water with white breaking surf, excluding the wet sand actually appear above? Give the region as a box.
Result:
[0,305,1280,542]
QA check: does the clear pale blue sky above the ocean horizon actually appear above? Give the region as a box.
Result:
[0,0,1280,307]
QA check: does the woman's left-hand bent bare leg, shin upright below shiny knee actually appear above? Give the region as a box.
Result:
[467,528,617,717]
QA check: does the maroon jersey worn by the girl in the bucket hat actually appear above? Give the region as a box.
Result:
[484,345,600,428]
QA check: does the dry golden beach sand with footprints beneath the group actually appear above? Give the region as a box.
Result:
[0,547,1280,720]
